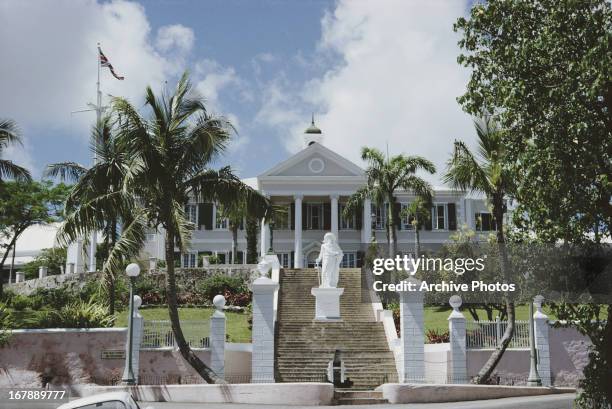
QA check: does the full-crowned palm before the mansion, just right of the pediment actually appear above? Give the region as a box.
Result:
[344,147,436,258]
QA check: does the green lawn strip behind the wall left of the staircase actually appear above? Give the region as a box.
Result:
[115,307,251,342]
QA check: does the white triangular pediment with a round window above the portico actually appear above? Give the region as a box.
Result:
[260,143,364,177]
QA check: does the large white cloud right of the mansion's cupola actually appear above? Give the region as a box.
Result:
[258,0,474,182]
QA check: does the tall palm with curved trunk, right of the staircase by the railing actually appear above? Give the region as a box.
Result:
[443,116,515,383]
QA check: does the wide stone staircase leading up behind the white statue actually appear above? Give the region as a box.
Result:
[275,269,397,388]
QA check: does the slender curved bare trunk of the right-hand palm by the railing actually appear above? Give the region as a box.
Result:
[474,195,516,384]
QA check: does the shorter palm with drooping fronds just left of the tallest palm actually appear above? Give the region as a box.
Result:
[45,116,137,315]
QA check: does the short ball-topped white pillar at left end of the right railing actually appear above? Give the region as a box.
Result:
[448,295,468,383]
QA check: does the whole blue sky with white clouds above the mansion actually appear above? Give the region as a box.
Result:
[0,0,473,181]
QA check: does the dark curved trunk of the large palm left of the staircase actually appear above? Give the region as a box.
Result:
[166,226,225,383]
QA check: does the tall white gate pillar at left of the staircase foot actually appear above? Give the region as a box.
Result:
[251,277,278,383]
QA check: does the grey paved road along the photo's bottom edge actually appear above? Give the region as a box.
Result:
[8,393,576,409]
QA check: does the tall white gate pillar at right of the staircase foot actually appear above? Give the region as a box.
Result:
[400,277,425,383]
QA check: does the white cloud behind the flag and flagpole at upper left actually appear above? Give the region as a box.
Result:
[0,0,193,174]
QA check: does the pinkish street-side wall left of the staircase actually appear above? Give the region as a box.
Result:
[0,328,252,388]
